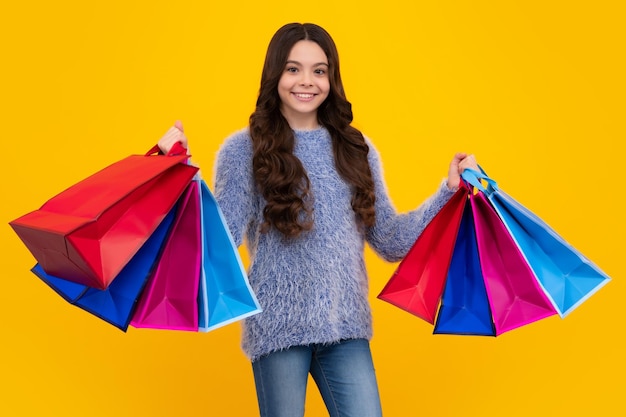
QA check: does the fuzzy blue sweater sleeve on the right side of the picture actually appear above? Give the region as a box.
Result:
[366,140,454,262]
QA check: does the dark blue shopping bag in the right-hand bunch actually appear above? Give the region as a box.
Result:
[433,199,496,336]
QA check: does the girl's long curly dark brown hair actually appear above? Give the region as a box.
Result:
[250,23,375,237]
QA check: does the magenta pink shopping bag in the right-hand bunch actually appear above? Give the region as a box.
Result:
[470,187,556,335]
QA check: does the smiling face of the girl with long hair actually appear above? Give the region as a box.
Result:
[278,41,330,129]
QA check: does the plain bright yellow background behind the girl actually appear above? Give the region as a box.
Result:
[0,0,626,416]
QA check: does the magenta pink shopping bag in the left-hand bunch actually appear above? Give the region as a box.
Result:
[130,181,201,331]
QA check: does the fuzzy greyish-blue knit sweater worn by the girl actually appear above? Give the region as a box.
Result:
[214,128,453,360]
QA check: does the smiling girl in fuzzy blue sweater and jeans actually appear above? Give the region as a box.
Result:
[159,23,477,417]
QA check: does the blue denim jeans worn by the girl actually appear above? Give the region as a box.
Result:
[252,339,382,417]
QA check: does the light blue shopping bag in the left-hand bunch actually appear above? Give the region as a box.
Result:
[198,179,261,332]
